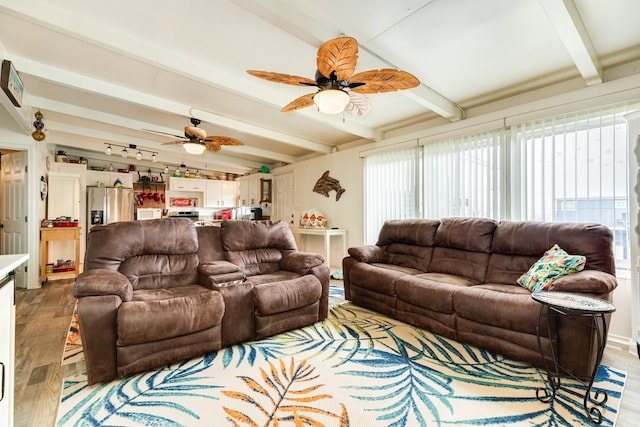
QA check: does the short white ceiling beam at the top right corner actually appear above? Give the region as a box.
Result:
[540,0,604,86]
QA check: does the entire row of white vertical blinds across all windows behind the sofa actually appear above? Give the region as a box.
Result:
[365,104,640,268]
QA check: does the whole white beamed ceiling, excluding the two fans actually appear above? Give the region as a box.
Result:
[0,0,640,173]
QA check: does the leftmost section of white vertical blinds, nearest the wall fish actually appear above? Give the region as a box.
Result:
[364,147,422,244]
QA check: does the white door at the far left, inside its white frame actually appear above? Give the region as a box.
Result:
[0,151,27,288]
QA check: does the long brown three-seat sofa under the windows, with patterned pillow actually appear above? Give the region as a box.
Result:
[343,218,617,377]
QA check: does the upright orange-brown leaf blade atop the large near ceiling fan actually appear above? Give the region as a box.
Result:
[316,37,358,80]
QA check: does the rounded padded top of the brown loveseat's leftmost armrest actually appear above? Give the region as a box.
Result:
[71,268,133,301]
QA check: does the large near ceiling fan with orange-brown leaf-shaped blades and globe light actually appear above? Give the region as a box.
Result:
[247,37,420,116]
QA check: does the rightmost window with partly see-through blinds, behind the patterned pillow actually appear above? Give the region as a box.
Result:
[511,106,629,269]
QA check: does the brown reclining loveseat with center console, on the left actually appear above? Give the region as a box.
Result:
[72,218,329,384]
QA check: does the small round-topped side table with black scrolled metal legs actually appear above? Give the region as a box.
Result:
[531,291,616,424]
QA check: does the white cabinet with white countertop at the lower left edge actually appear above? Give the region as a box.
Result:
[0,254,29,427]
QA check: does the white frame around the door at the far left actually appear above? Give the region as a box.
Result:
[0,139,42,289]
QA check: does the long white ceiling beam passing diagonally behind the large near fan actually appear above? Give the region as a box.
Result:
[232,0,464,122]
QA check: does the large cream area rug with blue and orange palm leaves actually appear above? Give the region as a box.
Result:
[57,286,626,427]
